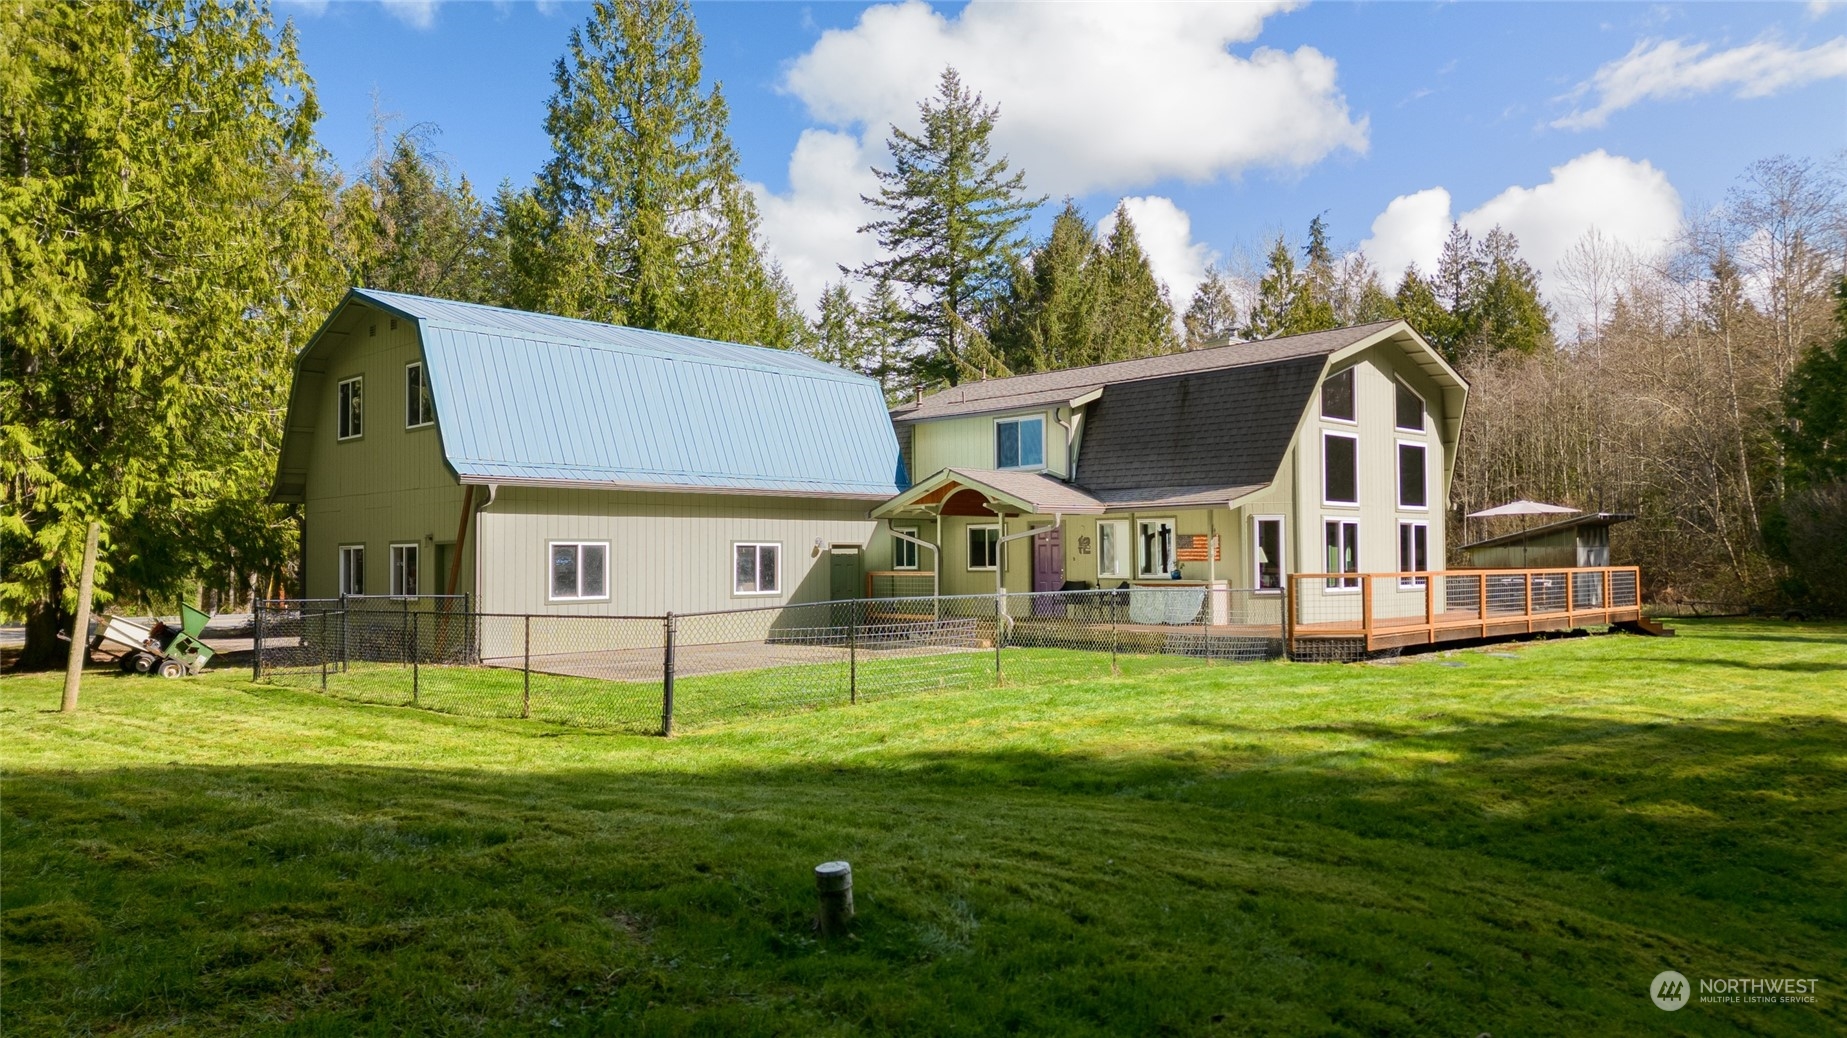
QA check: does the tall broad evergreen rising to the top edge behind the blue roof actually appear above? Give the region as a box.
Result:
[528,0,800,347]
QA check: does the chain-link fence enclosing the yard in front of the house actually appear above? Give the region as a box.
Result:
[255,587,1282,733]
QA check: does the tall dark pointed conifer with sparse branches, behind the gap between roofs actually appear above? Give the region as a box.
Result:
[855,68,1044,382]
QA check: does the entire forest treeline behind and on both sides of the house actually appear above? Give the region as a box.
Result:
[0,0,1847,663]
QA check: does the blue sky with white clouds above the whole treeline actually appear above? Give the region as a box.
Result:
[279,0,1847,319]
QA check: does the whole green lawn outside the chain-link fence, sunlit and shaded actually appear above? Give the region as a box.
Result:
[0,621,1847,1038]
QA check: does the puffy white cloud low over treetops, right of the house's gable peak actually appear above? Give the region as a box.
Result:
[1359,148,1681,318]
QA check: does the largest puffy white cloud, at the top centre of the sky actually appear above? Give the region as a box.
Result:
[783,0,1367,196]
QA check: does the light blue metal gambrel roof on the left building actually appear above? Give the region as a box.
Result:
[351,288,909,499]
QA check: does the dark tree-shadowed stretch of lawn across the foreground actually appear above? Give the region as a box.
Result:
[4,713,1847,1034]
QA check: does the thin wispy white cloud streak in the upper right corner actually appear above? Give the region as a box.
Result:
[1551,35,1847,129]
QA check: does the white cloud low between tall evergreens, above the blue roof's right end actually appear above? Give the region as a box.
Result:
[750,129,877,307]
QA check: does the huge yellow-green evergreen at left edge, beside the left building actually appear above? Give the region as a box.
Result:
[0,0,340,667]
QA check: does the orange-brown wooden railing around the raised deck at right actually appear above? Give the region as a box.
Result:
[1284,565,1642,652]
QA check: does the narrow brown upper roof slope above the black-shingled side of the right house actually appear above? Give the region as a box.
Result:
[892,321,1396,421]
